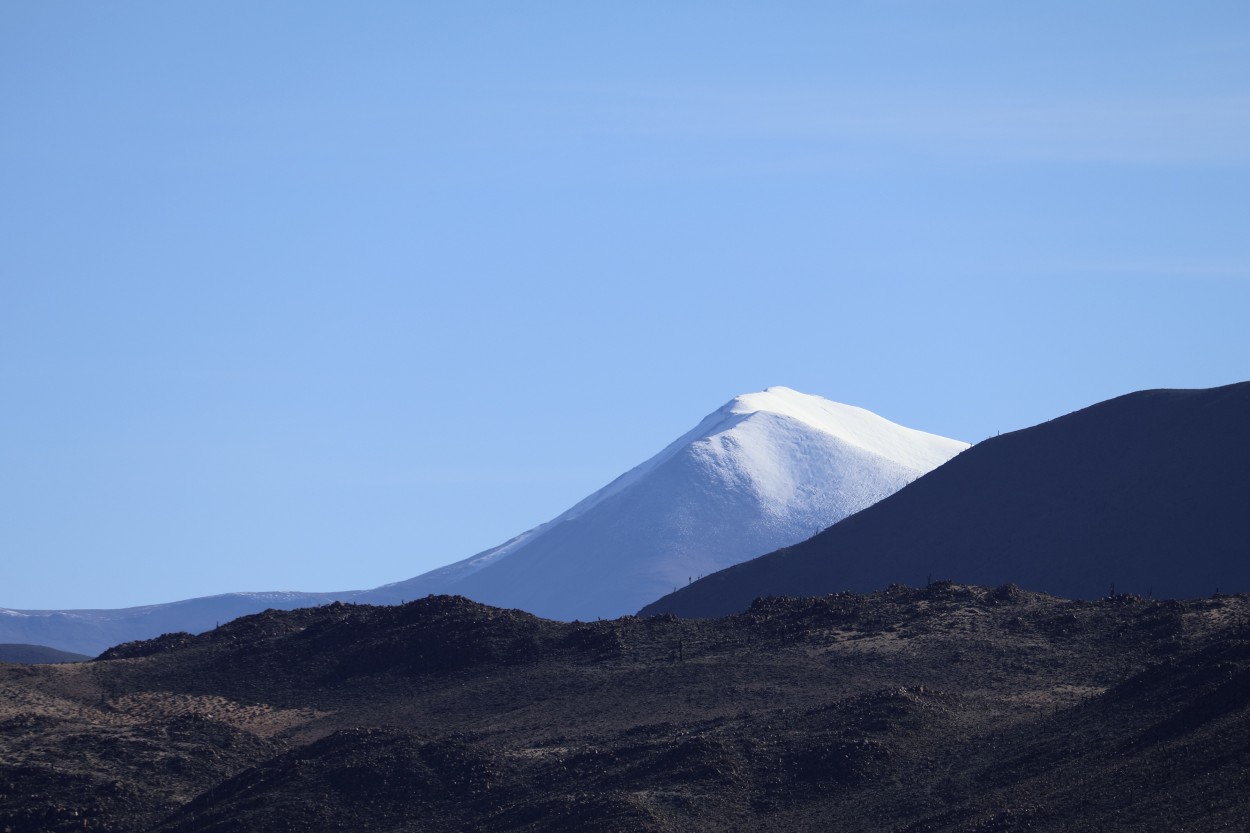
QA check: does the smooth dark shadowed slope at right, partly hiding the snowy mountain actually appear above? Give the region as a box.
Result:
[643,383,1250,617]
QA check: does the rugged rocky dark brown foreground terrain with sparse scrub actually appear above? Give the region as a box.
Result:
[0,583,1250,833]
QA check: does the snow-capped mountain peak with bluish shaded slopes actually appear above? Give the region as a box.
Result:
[361,388,968,619]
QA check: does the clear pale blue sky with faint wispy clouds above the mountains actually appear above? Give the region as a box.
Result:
[0,0,1250,608]
